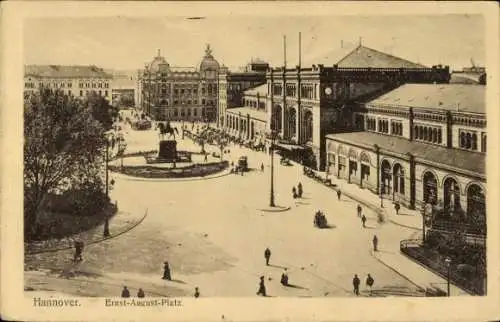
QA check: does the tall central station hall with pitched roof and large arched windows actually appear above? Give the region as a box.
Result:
[267,45,450,170]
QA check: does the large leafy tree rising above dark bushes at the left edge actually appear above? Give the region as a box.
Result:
[24,89,106,238]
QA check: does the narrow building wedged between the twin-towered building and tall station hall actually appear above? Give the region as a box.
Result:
[217,59,269,127]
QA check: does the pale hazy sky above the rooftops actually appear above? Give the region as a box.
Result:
[24,14,485,70]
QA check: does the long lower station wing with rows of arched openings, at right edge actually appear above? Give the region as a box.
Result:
[326,84,487,214]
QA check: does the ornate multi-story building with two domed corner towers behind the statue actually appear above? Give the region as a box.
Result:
[137,45,219,121]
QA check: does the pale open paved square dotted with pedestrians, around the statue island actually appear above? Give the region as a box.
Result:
[25,117,428,297]
